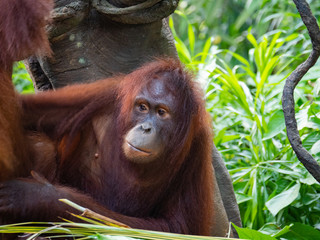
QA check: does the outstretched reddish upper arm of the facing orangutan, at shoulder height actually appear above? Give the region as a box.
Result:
[19,78,119,136]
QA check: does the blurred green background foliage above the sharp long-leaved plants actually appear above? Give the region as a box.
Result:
[173,0,320,65]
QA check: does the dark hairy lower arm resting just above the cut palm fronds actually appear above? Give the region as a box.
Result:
[0,179,188,232]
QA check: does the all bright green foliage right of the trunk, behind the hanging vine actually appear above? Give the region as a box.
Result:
[171,1,320,239]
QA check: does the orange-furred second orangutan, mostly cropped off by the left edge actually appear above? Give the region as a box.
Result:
[0,0,52,180]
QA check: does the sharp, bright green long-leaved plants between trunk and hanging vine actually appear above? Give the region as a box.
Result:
[208,29,320,232]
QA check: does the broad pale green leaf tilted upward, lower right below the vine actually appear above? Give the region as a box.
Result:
[266,183,300,216]
